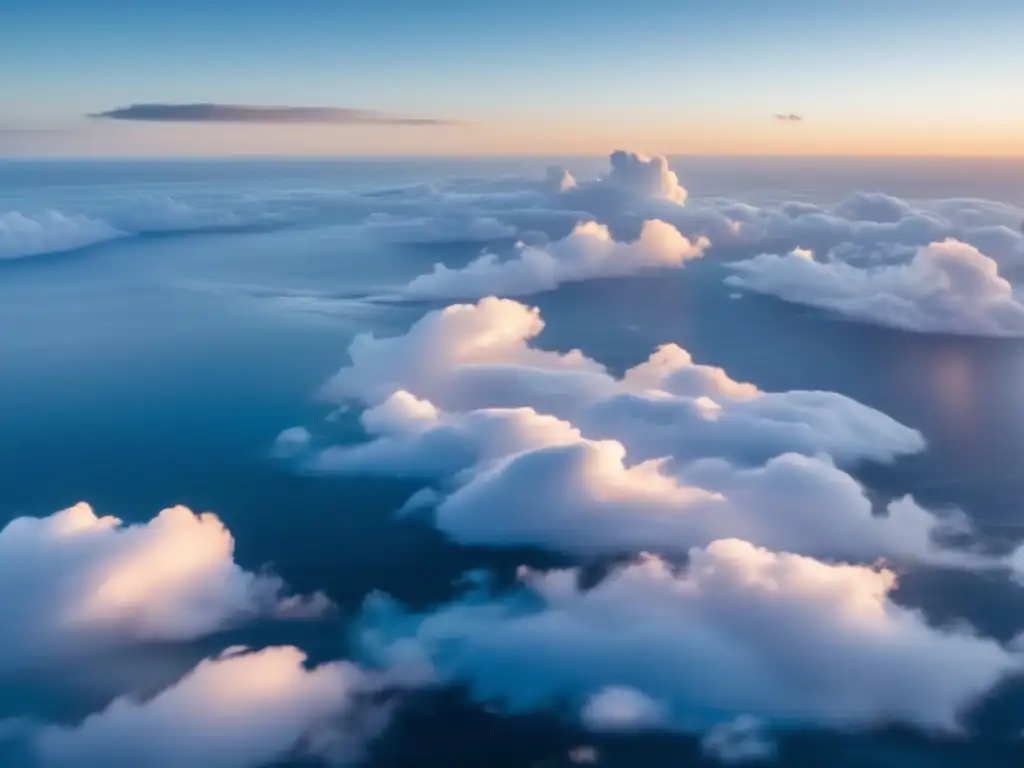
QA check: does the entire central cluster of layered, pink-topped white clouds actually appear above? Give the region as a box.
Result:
[306,298,974,564]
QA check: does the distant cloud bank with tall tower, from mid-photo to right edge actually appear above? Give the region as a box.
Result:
[358,152,1024,280]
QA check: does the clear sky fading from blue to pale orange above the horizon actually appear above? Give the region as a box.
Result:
[0,0,1024,156]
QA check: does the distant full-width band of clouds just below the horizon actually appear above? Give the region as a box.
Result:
[9,148,1024,278]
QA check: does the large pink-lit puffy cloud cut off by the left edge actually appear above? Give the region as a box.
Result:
[0,504,326,670]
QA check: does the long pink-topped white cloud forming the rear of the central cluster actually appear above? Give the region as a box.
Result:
[322,298,924,461]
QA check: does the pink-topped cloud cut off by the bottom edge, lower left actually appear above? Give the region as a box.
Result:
[24,646,415,768]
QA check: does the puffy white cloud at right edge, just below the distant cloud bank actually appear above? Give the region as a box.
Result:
[727,240,1024,336]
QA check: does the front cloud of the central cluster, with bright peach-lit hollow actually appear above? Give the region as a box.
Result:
[435,440,973,563]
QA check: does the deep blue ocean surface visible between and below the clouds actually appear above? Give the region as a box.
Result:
[0,158,1024,768]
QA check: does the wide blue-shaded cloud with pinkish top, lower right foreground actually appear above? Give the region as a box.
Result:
[361,540,1021,731]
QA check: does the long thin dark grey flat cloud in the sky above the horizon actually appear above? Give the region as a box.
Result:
[89,103,454,125]
